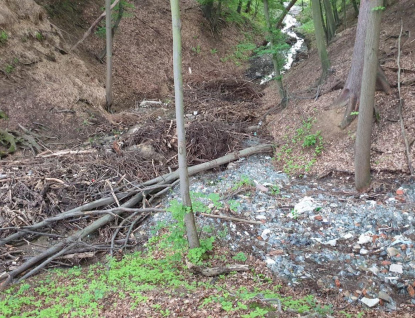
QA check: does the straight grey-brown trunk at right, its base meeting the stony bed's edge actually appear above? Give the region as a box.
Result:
[355,0,382,192]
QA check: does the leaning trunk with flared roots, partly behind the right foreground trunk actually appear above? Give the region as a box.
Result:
[332,1,391,129]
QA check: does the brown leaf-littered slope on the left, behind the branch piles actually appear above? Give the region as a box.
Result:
[0,0,256,148]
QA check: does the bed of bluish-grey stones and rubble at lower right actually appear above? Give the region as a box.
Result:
[141,156,415,310]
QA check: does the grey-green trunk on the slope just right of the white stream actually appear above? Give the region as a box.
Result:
[311,0,330,82]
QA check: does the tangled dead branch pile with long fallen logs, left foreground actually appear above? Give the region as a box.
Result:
[0,145,272,289]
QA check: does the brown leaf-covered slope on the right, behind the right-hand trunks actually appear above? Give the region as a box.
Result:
[263,0,415,174]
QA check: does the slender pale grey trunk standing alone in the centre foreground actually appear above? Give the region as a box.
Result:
[170,0,200,249]
